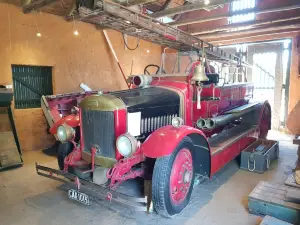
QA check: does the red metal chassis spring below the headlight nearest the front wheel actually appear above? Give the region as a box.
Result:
[106,150,145,190]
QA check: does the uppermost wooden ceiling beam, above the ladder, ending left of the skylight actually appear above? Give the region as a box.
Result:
[149,0,235,18]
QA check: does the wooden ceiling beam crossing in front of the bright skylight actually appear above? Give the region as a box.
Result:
[168,4,300,27]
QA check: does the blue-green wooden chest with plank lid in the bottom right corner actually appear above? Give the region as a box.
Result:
[248,181,300,224]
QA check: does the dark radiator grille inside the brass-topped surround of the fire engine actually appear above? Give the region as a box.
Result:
[81,109,116,158]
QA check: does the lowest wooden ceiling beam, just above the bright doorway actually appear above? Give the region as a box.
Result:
[197,22,300,40]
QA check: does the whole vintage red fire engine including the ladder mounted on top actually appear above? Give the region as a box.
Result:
[36,0,271,217]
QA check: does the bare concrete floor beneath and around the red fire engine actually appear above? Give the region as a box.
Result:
[0,132,297,225]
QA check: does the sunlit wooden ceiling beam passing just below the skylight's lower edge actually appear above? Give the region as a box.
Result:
[188,16,300,35]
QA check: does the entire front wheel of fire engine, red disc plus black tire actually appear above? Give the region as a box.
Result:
[152,138,195,217]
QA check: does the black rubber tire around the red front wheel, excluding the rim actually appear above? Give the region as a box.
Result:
[152,137,195,217]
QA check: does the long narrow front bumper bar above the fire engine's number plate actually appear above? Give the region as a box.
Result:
[35,163,146,211]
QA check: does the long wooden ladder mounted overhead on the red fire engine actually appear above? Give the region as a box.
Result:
[79,0,250,67]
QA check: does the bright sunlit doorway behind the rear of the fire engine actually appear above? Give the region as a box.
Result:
[223,39,291,130]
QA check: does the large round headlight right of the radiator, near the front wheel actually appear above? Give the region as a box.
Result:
[116,134,137,157]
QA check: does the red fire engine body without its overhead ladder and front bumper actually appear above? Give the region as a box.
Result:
[37,51,271,216]
